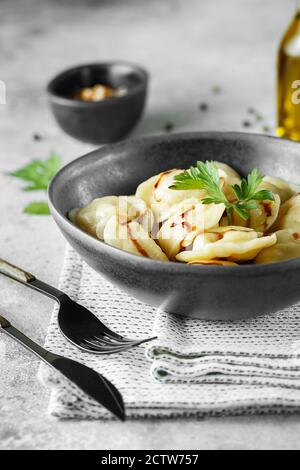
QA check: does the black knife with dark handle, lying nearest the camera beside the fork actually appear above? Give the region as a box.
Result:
[0,315,125,421]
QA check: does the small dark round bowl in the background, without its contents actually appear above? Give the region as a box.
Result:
[47,62,148,144]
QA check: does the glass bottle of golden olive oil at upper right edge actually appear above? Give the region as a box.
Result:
[277,0,300,141]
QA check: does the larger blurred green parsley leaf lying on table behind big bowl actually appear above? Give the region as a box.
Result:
[10,154,61,191]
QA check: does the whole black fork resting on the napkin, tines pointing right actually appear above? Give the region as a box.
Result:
[0,258,156,355]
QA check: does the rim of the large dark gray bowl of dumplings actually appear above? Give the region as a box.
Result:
[47,131,300,276]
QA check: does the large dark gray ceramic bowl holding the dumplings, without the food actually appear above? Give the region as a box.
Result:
[49,132,300,320]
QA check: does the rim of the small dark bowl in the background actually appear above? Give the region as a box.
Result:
[46,60,149,107]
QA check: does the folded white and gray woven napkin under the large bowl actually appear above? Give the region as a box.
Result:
[39,247,300,419]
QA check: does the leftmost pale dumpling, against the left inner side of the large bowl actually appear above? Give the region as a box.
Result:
[69,196,147,240]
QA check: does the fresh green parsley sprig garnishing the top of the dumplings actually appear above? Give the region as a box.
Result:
[170,161,274,224]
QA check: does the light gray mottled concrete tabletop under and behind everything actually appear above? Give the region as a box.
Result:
[0,0,300,449]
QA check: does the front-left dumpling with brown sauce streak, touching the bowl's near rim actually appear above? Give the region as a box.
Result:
[104,216,168,261]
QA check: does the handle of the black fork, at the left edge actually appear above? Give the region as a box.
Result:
[0,258,67,303]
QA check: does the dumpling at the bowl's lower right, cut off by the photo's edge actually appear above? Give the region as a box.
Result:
[255,230,300,264]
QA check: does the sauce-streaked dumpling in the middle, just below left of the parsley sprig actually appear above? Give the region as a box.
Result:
[157,203,225,259]
